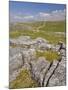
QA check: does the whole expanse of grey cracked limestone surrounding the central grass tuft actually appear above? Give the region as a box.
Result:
[9,36,66,87]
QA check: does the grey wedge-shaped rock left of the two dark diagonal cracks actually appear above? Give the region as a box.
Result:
[31,57,50,86]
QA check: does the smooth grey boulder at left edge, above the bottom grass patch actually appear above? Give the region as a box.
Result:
[9,53,23,73]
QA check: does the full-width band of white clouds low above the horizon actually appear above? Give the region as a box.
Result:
[10,9,66,22]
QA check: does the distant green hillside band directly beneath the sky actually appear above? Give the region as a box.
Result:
[9,21,66,32]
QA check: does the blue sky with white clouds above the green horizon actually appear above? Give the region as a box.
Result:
[9,1,66,22]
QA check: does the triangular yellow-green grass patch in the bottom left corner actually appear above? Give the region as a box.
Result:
[9,69,38,89]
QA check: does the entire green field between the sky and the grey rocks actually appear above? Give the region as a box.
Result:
[9,21,66,44]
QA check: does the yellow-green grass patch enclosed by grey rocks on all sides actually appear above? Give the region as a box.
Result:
[36,50,60,62]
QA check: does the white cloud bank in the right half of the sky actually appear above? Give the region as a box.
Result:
[38,9,66,21]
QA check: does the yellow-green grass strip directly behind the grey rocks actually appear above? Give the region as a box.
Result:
[9,30,65,44]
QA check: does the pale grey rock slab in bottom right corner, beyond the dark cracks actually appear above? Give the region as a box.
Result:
[48,58,66,86]
